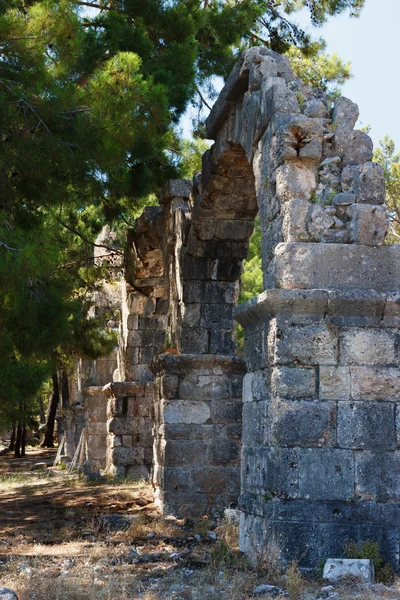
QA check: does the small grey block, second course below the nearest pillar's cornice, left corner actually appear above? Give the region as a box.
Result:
[271,366,317,398]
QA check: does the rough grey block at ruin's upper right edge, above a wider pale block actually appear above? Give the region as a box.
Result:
[342,162,385,204]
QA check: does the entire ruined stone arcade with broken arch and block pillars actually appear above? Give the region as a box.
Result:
[58,48,400,569]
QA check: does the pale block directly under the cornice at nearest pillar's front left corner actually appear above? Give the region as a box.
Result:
[271,325,338,365]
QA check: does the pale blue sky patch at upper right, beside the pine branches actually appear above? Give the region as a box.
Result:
[181,0,400,152]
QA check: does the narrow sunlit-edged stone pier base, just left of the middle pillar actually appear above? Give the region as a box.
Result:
[103,382,154,479]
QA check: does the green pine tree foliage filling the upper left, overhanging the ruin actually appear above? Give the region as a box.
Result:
[0,0,364,420]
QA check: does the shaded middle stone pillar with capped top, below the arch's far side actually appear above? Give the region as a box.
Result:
[153,354,245,516]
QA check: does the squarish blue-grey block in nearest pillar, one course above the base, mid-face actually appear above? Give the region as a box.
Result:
[299,448,354,501]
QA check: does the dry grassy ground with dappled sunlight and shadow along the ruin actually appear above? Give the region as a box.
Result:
[0,449,400,600]
